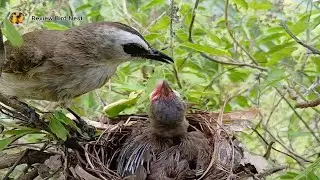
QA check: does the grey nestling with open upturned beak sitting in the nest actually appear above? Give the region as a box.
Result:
[117,81,213,180]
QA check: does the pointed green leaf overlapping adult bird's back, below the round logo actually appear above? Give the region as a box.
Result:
[3,18,23,47]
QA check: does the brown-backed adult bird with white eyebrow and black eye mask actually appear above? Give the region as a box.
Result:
[0,22,173,125]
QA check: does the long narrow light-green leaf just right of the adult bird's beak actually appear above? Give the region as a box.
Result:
[180,42,231,56]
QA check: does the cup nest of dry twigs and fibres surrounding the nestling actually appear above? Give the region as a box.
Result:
[69,110,278,180]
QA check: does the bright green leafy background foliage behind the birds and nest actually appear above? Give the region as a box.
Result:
[0,0,320,179]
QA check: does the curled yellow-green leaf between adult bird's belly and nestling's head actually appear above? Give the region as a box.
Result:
[103,91,142,117]
